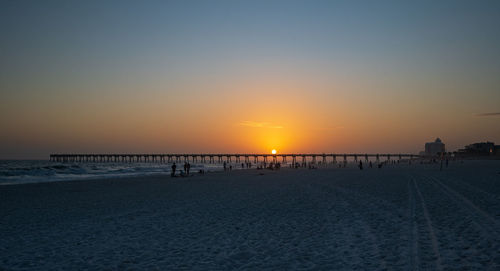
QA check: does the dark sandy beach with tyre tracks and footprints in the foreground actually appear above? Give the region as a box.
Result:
[0,161,500,270]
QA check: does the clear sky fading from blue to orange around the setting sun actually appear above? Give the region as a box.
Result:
[0,0,500,159]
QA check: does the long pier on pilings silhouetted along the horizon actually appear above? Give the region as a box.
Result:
[50,153,419,164]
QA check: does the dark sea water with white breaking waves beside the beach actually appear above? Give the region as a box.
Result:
[0,160,221,185]
